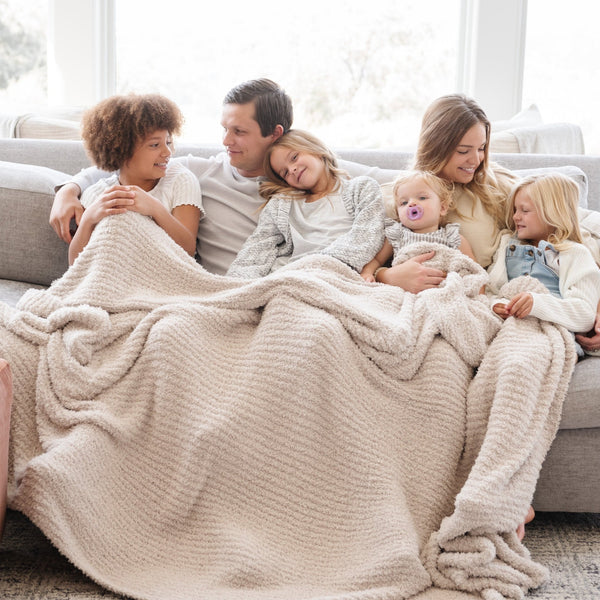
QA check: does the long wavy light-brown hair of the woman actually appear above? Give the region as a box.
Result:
[414,94,514,229]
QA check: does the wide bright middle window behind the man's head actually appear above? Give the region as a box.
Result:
[116,0,461,148]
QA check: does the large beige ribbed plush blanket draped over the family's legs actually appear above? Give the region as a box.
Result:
[0,213,575,600]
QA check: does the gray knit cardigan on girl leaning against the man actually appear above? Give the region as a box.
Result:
[227,176,384,278]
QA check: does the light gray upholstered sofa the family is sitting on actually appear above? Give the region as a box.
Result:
[0,139,600,513]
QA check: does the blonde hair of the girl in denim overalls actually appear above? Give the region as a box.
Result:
[506,173,583,251]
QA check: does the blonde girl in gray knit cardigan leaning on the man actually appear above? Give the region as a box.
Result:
[227,130,384,278]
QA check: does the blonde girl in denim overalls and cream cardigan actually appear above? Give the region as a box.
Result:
[488,173,600,356]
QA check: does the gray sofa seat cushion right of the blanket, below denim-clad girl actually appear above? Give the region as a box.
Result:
[560,356,600,429]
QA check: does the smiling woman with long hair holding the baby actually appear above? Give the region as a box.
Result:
[377,94,516,293]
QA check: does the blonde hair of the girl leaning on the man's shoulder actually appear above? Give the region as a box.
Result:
[259,129,348,200]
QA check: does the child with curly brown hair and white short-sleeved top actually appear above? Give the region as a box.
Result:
[69,94,204,264]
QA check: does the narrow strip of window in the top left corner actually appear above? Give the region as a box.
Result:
[0,0,48,113]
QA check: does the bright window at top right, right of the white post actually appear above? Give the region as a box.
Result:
[523,0,600,154]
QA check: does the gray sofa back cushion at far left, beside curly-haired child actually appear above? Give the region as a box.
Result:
[0,161,68,285]
